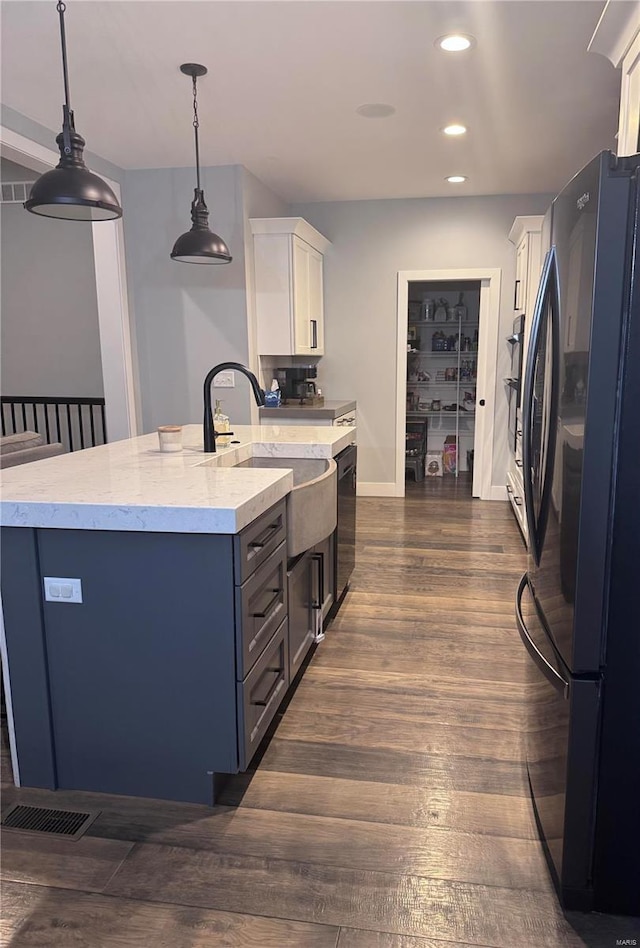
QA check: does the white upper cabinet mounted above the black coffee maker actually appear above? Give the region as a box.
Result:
[251,217,330,356]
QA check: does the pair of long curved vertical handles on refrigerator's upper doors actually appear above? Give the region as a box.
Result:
[522,246,560,564]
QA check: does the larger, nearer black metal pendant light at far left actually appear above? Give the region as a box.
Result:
[24,0,122,221]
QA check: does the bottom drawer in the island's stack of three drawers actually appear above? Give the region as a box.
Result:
[237,619,289,770]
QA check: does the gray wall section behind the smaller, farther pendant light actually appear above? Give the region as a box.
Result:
[123,166,250,431]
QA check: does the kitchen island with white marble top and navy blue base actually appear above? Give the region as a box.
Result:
[1,425,354,803]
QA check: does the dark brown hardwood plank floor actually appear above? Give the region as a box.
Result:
[1,477,640,948]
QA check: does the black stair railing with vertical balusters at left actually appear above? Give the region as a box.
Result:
[0,395,107,451]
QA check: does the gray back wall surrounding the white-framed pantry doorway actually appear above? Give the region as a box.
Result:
[292,195,552,485]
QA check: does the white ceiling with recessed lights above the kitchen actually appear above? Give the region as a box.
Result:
[1,0,620,202]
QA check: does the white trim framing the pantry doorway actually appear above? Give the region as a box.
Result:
[395,267,504,500]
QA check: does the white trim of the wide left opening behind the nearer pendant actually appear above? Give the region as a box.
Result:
[0,125,138,441]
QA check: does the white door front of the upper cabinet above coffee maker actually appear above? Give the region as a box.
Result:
[292,235,324,355]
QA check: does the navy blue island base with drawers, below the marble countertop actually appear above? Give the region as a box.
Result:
[1,501,289,804]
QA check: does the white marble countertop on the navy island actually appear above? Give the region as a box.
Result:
[0,425,355,533]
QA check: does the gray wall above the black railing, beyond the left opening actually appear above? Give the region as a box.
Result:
[0,162,103,396]
